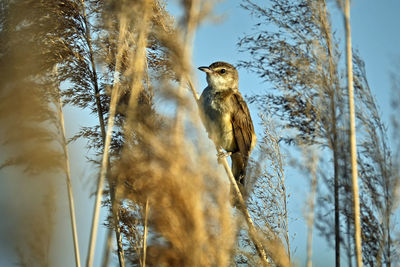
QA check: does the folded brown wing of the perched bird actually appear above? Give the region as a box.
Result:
[231,92,255,159]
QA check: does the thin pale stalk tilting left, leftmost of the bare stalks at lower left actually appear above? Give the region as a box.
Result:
[54,65,81,267]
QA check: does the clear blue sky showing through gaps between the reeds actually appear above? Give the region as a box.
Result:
[0,0,400,267]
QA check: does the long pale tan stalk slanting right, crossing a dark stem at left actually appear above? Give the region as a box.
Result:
[86,13,127,267]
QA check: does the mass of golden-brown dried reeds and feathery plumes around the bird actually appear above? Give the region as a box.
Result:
[0,0,400,266]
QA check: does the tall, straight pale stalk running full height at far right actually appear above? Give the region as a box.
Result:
[344,0,363,267]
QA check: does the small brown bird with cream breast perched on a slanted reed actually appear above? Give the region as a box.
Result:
[199,62,257,186]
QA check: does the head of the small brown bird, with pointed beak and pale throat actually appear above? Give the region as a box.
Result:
[199,61,239,91]
